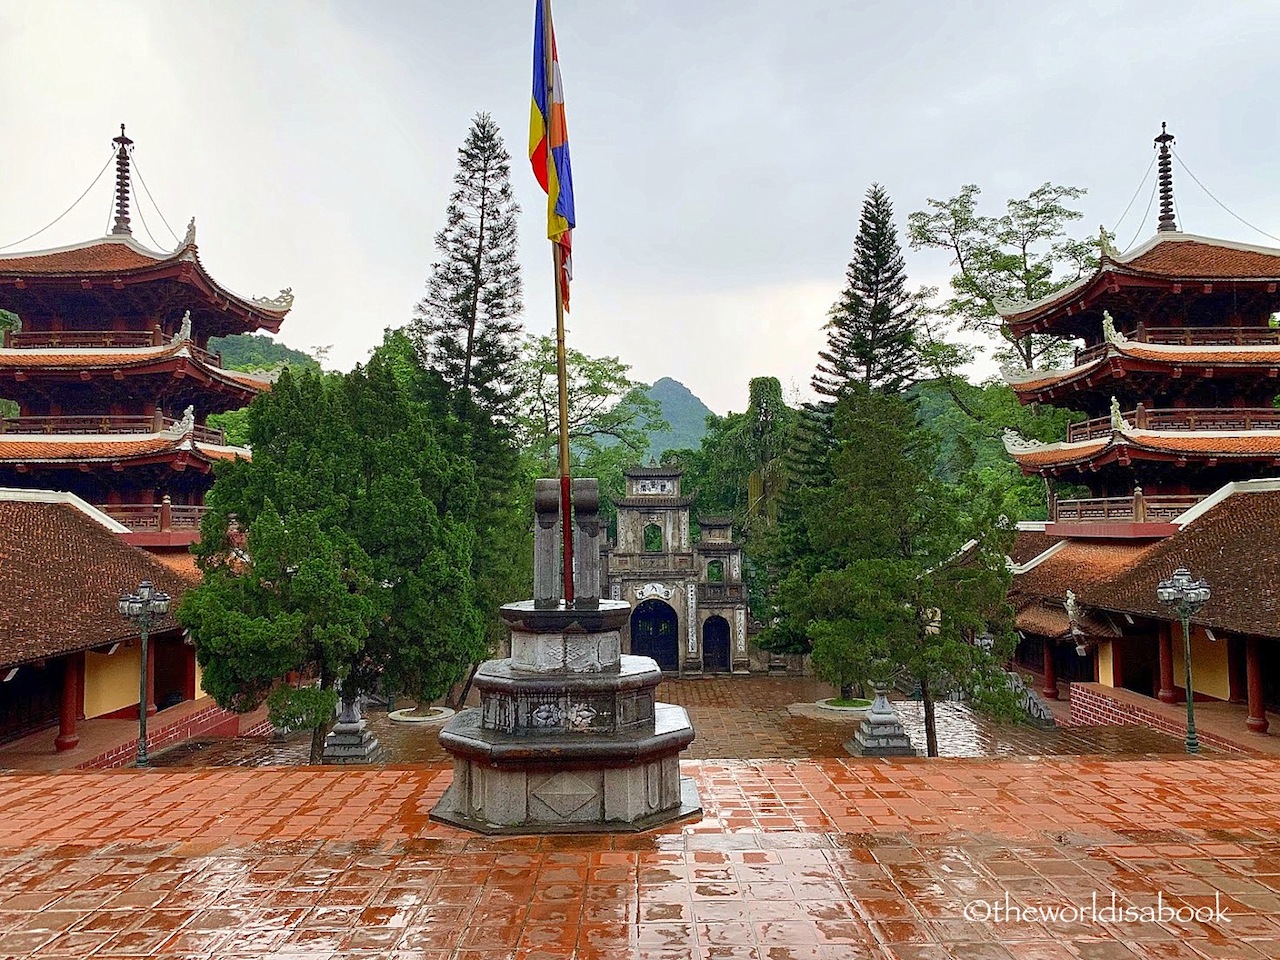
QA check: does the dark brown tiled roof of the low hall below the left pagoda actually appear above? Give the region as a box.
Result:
[0,499,188,667]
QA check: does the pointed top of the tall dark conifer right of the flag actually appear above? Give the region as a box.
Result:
[813,183,920,403]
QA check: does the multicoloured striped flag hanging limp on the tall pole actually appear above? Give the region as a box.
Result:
[529,0,575,310]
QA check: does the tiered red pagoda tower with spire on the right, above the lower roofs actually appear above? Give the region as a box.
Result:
[1001,125,1280,539]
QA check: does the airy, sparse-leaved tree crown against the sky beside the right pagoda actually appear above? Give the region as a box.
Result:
[908,183,1098,370]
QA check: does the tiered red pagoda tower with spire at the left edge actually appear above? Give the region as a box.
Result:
[0,124,293,548]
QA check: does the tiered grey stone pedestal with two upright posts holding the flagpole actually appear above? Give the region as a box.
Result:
[431,480,701,833]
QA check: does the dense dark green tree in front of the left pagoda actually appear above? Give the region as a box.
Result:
[179,355,485,762]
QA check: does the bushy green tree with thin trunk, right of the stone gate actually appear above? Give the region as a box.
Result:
[773,388,1012,756]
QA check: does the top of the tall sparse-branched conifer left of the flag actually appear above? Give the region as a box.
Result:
[411,113,524,424]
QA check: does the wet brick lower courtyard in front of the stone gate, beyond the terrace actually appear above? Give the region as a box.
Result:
[155,677,1183,767]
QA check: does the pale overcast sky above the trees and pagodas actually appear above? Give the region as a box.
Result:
[0,0,1280,412]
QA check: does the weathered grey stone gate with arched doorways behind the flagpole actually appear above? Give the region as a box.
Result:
[602,466,750,675]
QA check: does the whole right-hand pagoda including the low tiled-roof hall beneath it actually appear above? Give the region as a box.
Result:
[1002,131,1280,732]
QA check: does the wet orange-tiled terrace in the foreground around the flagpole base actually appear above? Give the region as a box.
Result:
[0,756,1280,960]
